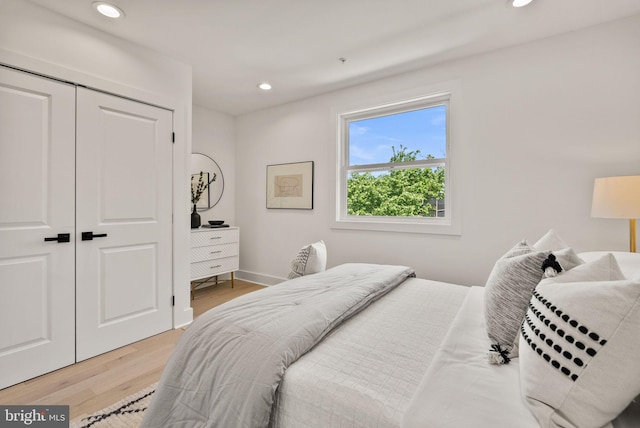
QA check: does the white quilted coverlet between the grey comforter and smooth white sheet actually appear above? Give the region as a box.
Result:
[271,278,470,428]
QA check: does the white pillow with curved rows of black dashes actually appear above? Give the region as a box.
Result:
[519,255,640,428]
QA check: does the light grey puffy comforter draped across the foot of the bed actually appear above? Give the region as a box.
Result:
[142,264,414,428]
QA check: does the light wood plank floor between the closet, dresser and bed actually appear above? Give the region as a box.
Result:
[0,279,264,420]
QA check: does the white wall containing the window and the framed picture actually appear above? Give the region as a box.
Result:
[236,16,640,284]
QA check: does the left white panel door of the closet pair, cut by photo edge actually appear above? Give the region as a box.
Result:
[0,67,75,388]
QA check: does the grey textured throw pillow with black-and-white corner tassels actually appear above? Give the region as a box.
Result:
[484,241,549,364]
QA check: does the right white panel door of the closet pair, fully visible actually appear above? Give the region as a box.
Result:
[76,88,173,361]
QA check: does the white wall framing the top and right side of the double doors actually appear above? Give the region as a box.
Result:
[0,0,192,326]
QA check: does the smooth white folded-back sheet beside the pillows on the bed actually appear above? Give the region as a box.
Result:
[403,287,540,428]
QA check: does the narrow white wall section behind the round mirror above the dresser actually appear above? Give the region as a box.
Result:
[192,105,236,226]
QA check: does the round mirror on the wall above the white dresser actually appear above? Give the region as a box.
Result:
[191,153,224,211]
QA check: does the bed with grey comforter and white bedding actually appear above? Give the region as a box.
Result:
[142,237,640,428]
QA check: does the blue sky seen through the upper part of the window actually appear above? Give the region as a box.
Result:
[349,105,446,165]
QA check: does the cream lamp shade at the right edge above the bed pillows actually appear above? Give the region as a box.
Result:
[591,175,640,219]
